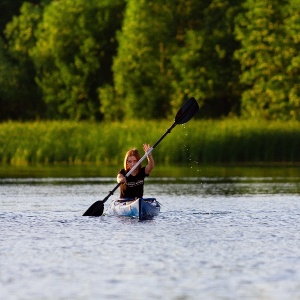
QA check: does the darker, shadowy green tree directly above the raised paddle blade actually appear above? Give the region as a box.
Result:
[172,0,241,117]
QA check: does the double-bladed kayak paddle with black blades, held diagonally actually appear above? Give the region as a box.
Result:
[83,97,199,217]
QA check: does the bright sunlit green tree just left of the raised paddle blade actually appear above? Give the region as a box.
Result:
[108,0,179,119]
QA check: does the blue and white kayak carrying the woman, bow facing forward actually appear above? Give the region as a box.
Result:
[105,198,160,220]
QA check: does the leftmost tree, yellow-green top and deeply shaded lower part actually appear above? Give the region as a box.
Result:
[0,2,44,120]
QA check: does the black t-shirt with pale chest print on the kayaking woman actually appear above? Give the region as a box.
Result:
[119,167,149,198]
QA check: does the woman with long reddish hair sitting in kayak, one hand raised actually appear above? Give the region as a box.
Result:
[117,144,154,198]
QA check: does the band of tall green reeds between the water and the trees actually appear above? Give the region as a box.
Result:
[0,120,300,165]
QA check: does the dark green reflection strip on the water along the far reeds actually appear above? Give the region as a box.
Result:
[0,177,300,196]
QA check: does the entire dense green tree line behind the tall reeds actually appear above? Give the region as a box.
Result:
[0,0,300,120]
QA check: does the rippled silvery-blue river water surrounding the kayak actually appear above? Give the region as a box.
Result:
[0,177,300,300]
